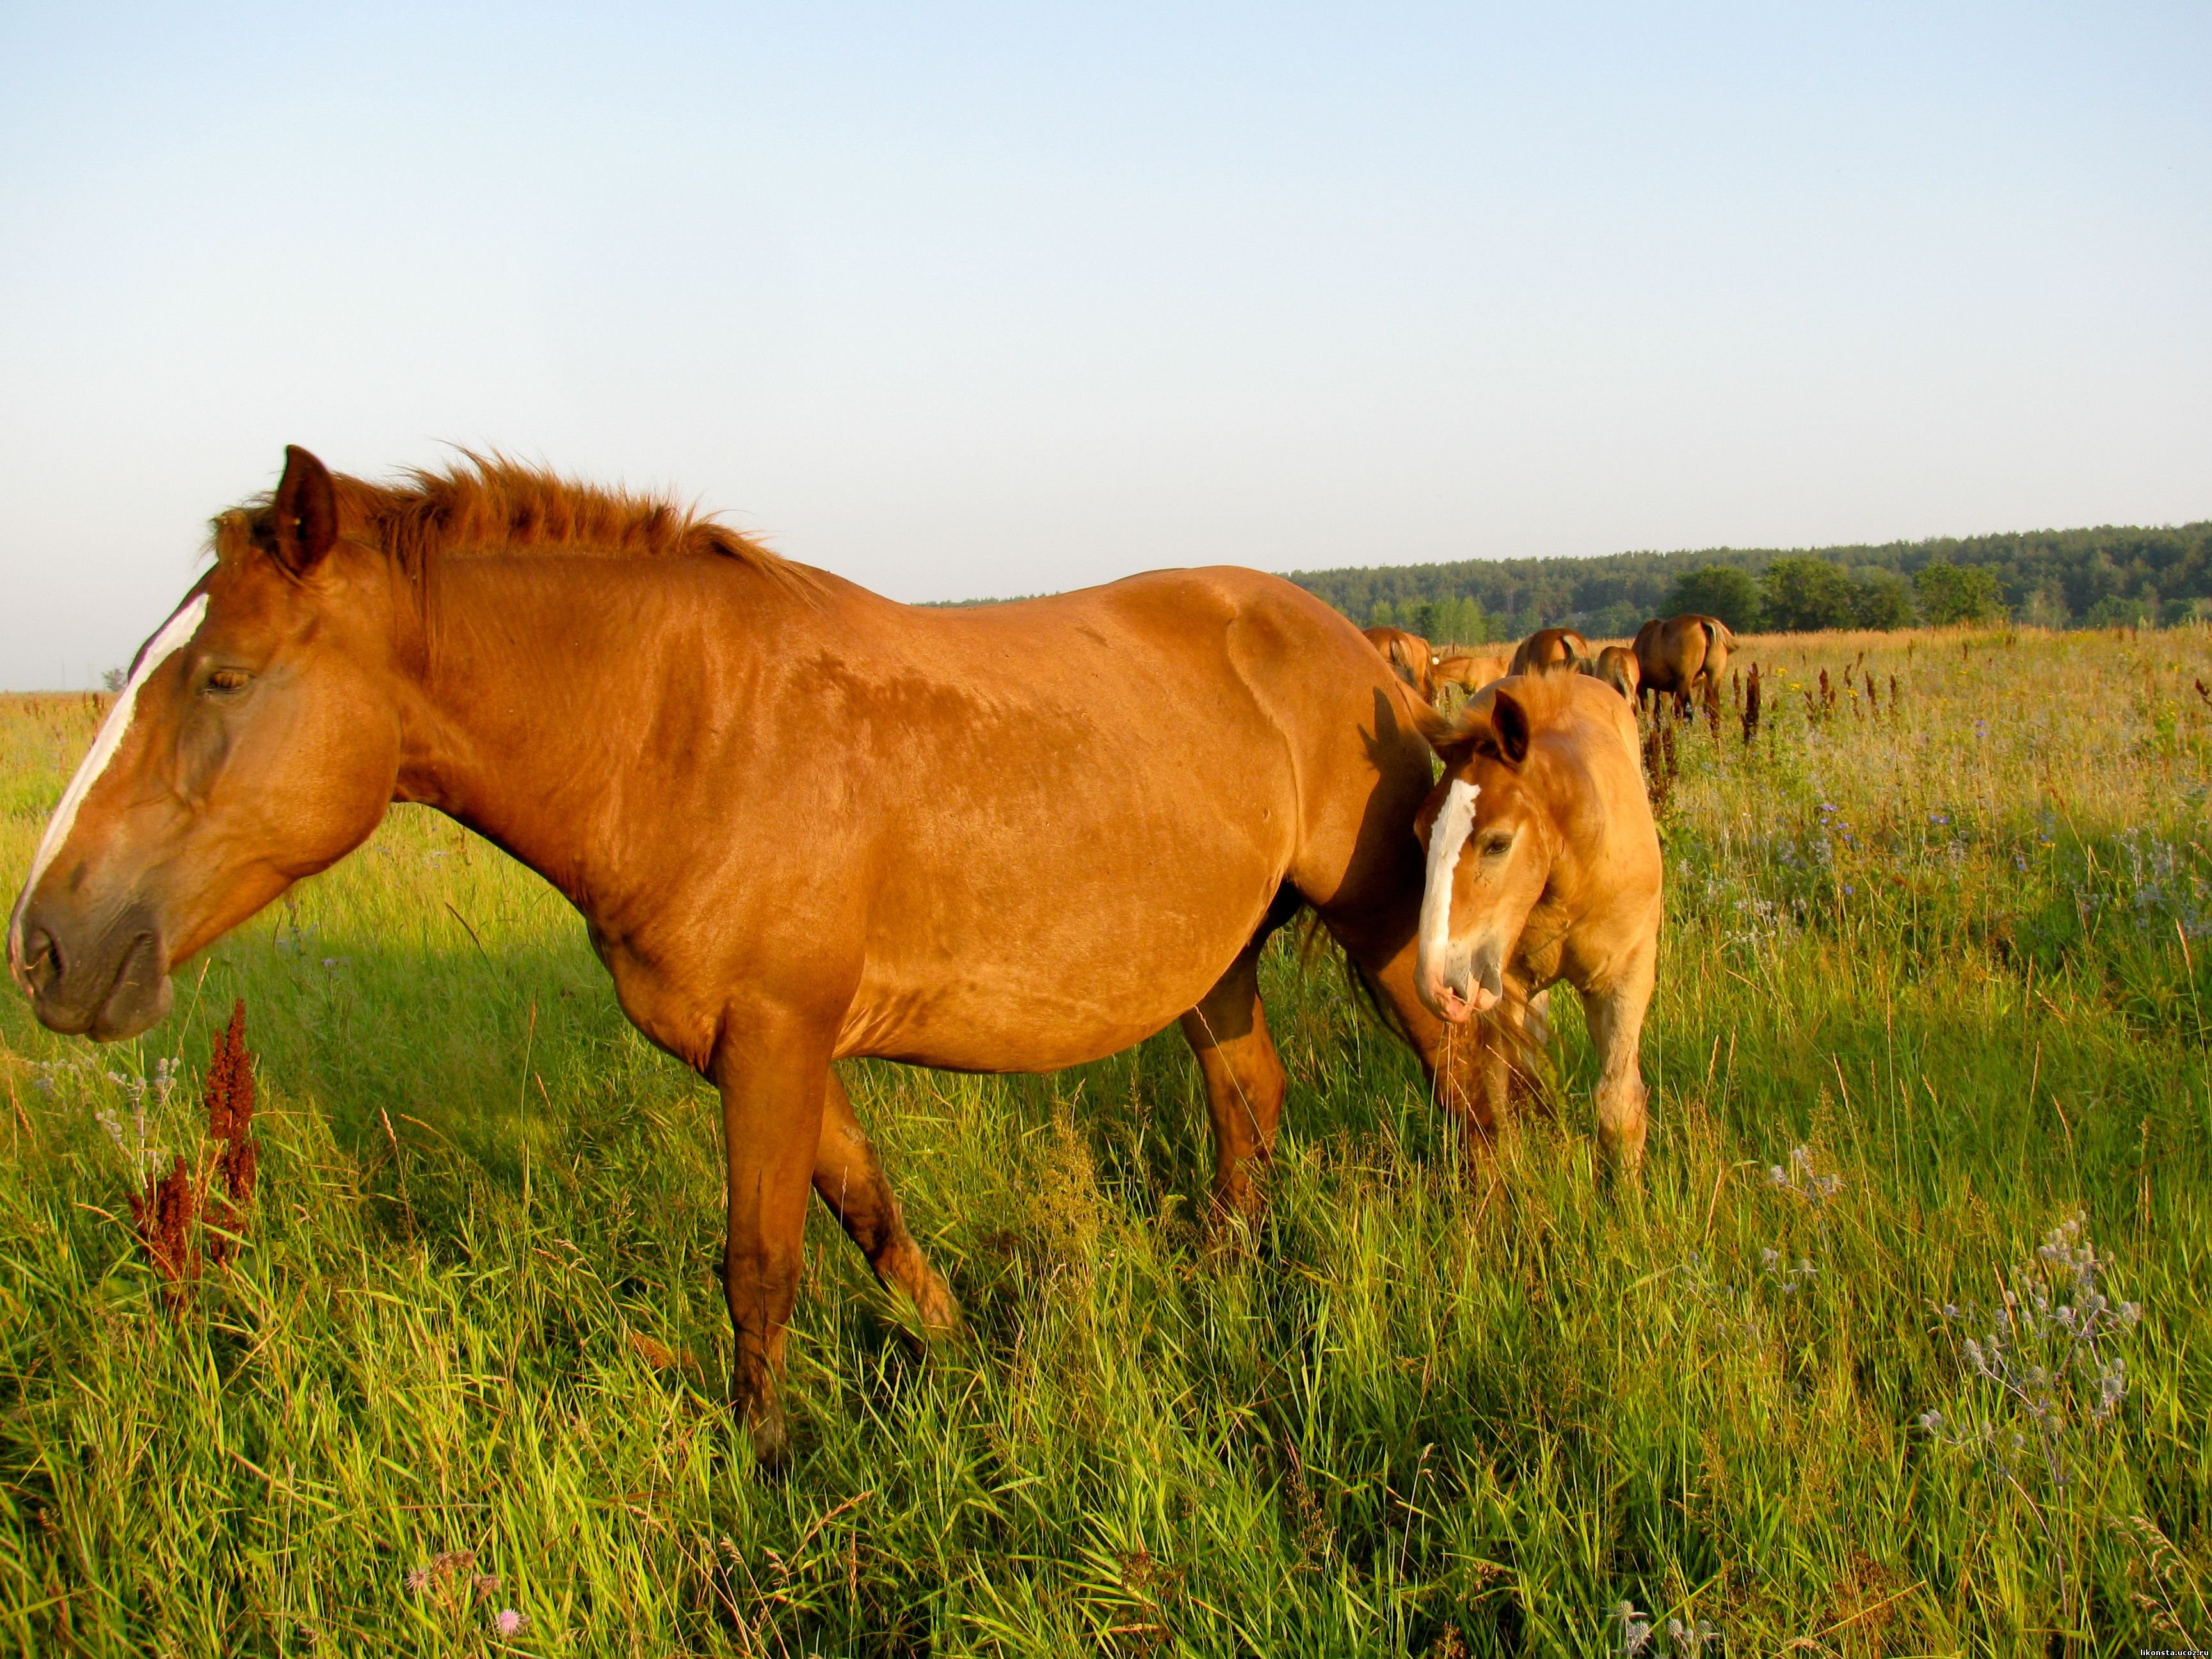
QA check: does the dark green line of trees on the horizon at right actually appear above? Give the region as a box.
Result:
[1290,520,2212,644]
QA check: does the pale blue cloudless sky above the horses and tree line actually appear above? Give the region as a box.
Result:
[0,4,2212,688]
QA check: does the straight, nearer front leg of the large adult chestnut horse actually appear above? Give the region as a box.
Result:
[714,1020,834,1462]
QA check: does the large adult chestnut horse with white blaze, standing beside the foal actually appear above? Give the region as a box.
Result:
[9,449,1480,1458]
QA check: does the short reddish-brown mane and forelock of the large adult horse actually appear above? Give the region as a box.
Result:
[214,449,801,579]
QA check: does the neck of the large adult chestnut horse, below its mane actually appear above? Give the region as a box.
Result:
[396,557,769,913]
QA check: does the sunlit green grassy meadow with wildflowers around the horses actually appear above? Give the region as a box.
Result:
[0,630,2212,1659]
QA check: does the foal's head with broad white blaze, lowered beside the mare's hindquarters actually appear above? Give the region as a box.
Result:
[1413,685,1559,1024]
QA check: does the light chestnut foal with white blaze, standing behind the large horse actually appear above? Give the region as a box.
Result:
[1418,673,1661,1170]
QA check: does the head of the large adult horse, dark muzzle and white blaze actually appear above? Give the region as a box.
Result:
[6,449,401,1039]
